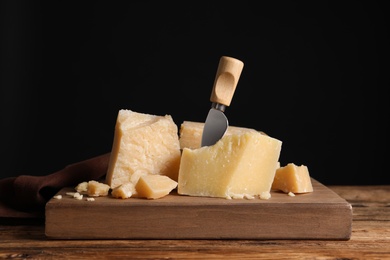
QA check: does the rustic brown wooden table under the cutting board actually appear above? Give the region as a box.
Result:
[0,185,390,259]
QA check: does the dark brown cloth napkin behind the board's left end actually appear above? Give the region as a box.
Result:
[0,153,110,218]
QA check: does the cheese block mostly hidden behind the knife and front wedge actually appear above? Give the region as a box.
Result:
[179,121,257,149]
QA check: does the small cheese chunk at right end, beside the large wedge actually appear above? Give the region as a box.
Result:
[272,163,313,193]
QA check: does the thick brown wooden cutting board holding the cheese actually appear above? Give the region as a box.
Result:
[45,179,352,240]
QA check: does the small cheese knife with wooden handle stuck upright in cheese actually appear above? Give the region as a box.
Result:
[201,56,244,146]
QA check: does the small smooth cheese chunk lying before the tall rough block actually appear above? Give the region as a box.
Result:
[135,175,177,199]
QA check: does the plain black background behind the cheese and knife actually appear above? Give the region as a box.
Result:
[0,1,390,185]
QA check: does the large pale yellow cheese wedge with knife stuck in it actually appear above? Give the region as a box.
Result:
[177,131,282,199]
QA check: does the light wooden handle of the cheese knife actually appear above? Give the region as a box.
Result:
[210,56,244,106]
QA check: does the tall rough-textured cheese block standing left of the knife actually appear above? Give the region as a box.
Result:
[106,109,181,189]
